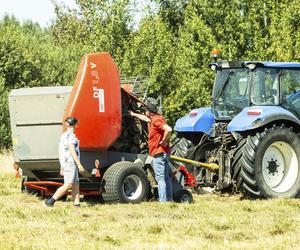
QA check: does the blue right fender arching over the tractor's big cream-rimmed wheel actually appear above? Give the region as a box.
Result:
[227,106,300,132]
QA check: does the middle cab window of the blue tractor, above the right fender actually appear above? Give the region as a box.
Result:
[251,68,279,105]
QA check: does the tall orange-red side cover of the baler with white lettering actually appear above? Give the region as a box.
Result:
[64,52,122,150]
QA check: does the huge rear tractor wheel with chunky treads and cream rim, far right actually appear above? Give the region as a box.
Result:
[233,126,300,198]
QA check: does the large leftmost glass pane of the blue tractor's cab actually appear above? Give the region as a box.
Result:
[213,68,249,120]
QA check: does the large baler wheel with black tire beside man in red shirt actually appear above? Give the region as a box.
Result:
[102,161,149,203]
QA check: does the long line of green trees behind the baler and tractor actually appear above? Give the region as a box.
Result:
[0,0,300,148]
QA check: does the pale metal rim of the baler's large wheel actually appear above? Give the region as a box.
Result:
[122,175,143,200]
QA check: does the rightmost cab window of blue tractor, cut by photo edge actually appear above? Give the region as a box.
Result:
[281,70,300,116]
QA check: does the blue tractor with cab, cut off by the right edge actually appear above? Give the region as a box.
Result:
[173,58,300,198]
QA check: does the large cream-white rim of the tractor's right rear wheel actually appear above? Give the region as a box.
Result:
[262,141,298,193]
